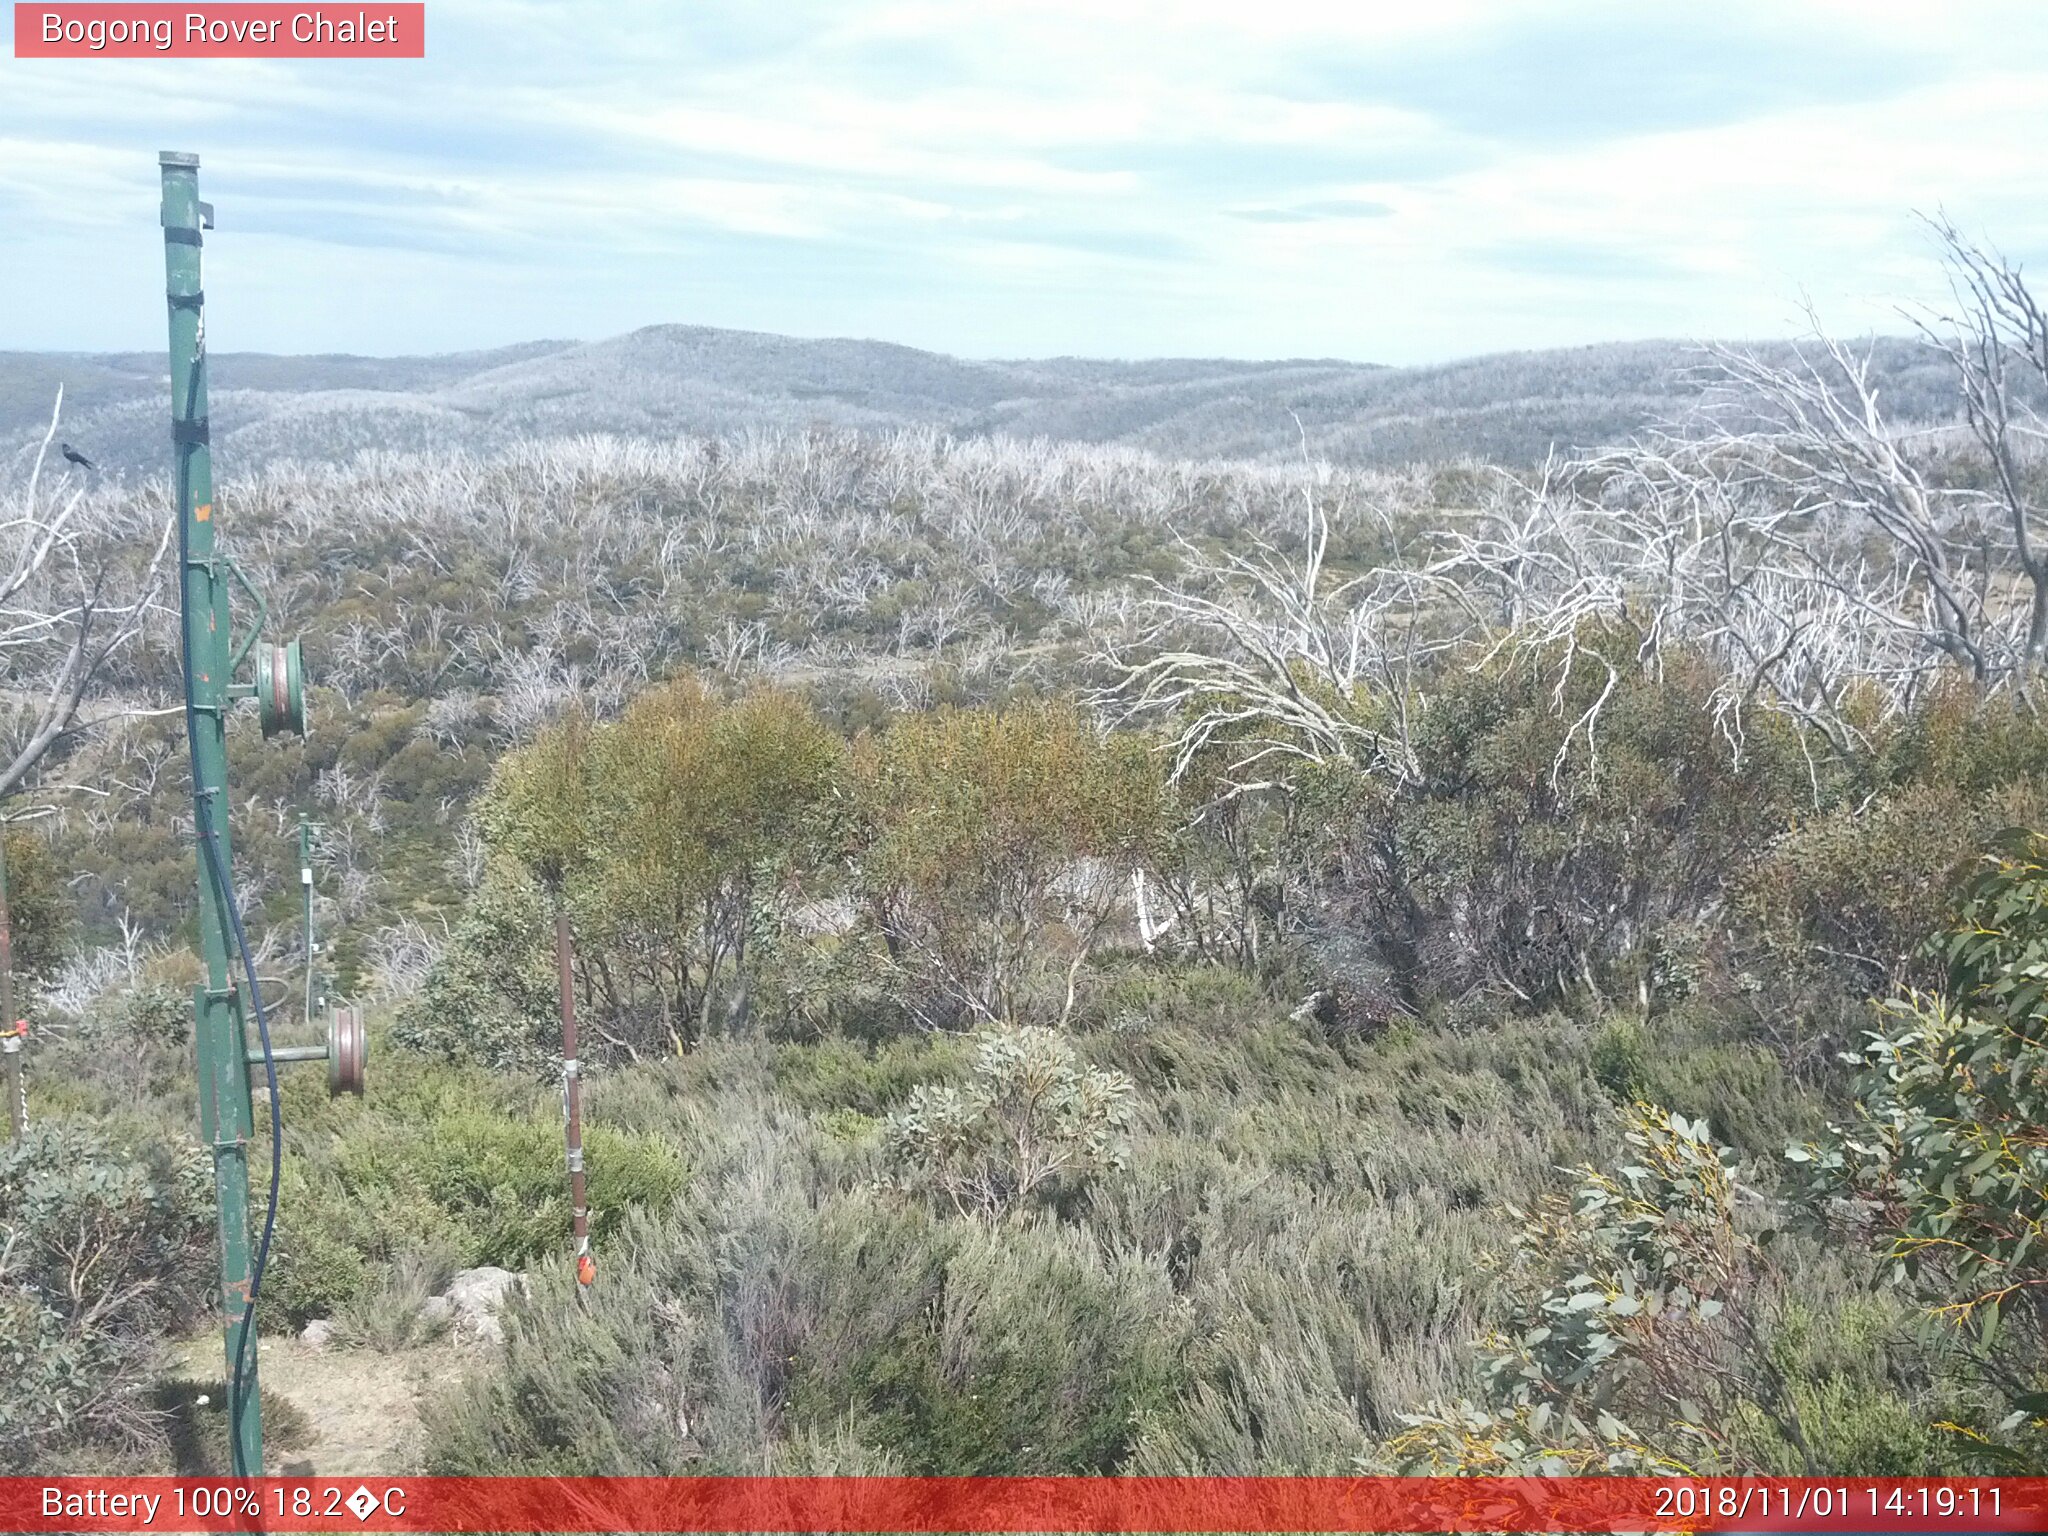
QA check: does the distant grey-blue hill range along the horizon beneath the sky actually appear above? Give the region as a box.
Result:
[0,326,1946,473]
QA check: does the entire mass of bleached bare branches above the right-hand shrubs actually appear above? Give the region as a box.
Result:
[1102,221,2048,793]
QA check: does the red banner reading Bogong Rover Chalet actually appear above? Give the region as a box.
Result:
[14,0,426,59]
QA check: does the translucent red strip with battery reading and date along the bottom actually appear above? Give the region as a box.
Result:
[0,1477,2048,1534]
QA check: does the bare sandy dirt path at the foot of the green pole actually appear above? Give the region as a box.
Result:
[172,1335,477,1477]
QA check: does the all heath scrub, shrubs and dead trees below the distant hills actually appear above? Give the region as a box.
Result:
[12,227,2048,1475]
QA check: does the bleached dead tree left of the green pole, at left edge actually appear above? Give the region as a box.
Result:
[0,389,172,797]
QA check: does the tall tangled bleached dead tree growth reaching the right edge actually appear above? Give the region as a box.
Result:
[1430,221,2048,782]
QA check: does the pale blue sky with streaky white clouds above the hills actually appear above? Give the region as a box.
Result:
[0,0,2048,362]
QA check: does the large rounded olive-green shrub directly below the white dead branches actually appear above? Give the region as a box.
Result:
[1327,647,1806,1004]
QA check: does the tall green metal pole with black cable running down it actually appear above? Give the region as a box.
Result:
[158,152,262,1477]
